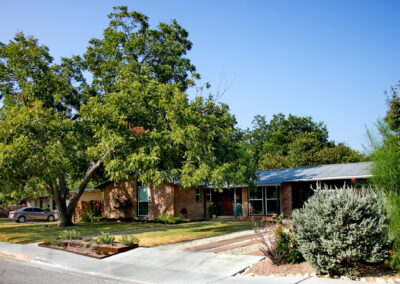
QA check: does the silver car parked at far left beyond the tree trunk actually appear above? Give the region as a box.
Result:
[8,207,58,223]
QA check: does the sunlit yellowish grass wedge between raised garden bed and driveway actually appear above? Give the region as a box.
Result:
[116,221,252,247]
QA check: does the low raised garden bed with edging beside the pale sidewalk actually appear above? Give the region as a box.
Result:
[38,240,139,259]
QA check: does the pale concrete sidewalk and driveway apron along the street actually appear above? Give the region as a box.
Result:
[0,242,380,284]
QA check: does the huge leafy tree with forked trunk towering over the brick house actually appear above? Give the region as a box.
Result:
[0,7,251,226]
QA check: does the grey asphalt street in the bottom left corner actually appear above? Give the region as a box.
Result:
[0,259,137,284]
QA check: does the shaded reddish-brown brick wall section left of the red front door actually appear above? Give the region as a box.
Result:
[174,187,206,219]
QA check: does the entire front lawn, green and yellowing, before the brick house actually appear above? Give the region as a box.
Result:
[0,221,251,246]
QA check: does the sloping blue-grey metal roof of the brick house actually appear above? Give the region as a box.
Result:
[256,162,372,185]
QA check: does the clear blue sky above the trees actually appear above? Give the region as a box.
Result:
[0,0,400,150]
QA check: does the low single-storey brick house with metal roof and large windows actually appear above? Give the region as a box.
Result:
[75,162,371,220]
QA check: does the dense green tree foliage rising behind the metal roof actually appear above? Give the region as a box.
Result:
[246,114,363,169]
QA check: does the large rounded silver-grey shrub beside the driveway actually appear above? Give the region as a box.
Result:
[292,187,388,276]
